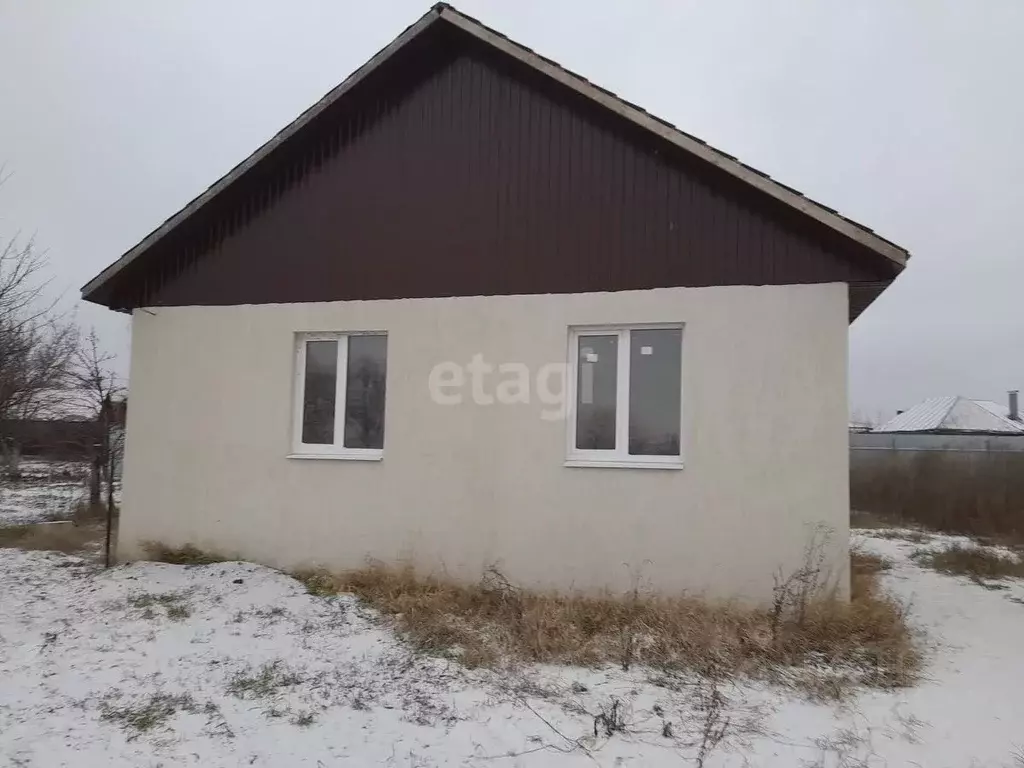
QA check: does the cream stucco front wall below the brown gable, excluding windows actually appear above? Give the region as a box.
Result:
[119,284,849,600]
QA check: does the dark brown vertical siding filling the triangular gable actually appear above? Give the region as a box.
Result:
[112,35,896,316]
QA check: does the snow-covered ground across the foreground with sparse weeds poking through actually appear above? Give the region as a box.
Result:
[0,535,1024,768]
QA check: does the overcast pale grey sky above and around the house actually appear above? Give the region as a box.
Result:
[0,0,1024,416]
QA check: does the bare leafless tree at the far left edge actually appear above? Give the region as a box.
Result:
[0,228,78,468]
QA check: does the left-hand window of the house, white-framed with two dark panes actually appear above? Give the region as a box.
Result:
[293,333,387,460]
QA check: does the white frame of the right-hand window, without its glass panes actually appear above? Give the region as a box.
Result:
[565,323,686,469]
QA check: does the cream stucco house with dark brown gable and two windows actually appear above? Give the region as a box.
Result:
[83,4,907,601]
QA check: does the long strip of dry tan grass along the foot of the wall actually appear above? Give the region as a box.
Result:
[300,554,921,696]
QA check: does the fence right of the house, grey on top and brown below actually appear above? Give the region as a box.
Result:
[850,433,1024,536]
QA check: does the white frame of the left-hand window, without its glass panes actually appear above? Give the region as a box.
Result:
[288,331,387,461]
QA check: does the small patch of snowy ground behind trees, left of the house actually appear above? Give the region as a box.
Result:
[0,460,88,527]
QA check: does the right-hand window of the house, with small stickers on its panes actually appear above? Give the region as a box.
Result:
[568,326,683,467]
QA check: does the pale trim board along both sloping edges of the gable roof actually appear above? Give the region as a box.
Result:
[82,3,909,303]
